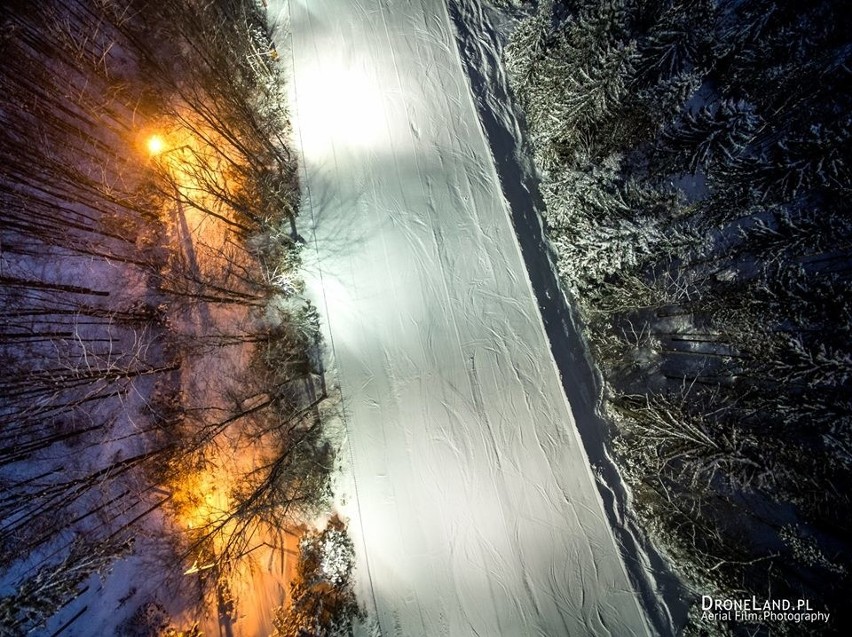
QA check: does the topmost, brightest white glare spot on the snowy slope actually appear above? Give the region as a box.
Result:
[298,68,385,148]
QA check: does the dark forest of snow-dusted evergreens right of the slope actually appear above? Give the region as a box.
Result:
[501,0,852,635]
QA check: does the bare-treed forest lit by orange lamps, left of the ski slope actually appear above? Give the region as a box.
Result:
[0,0,358,636]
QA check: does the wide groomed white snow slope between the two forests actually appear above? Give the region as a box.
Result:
[269,0,649,637]
